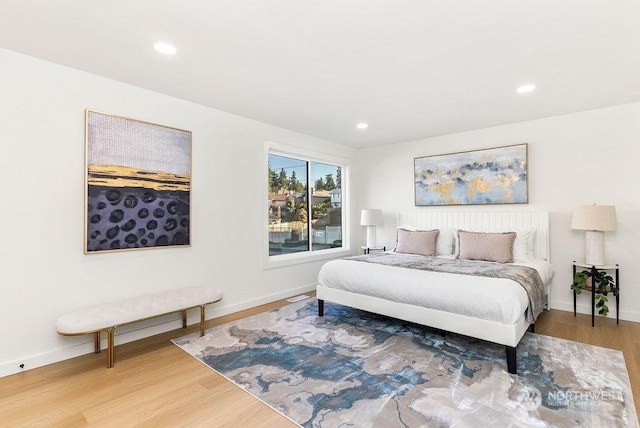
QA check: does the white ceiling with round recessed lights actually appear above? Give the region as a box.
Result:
[0,0,640,148]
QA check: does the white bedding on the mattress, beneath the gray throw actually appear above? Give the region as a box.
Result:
[318,255,553,325]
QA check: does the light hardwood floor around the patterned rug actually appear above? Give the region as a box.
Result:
[0,300,640,427]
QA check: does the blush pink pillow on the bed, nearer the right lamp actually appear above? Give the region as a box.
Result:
[458,230,516,263]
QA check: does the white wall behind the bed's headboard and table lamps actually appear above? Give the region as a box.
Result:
[355,103,640,321]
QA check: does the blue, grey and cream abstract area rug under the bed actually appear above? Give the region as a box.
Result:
[174,299,638,428]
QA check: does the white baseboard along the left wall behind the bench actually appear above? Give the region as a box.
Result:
[0,283,316,378]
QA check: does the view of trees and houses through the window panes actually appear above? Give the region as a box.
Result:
[268,153,342,256]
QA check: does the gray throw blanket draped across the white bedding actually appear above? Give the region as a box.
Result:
[346,253,546,324]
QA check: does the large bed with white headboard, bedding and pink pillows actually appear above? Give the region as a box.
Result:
[316,211,553,373]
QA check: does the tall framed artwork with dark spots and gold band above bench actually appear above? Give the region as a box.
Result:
[84,109,192,254]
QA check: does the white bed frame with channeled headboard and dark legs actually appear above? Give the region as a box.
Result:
[316,210,549,373]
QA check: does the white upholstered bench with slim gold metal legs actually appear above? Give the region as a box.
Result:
[56,286,222,368]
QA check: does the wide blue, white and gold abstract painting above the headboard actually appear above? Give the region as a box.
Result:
[414,143,529,207]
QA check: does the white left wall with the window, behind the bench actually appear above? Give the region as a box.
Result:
[0,50,355,376]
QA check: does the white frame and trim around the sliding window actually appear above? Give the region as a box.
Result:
[262,141,351,269]
